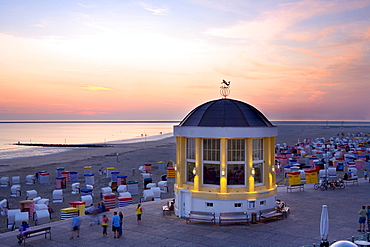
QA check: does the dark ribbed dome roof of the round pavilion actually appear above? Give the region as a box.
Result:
[179,99,274,127]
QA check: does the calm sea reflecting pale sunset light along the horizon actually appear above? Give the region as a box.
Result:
[0,120,370,160]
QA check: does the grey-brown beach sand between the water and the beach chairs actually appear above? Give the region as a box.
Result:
[0,125,370,232]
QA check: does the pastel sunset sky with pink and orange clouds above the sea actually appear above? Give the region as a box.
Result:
[0,0,370,120]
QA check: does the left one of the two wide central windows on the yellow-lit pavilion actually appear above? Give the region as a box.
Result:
[203,139,221,185]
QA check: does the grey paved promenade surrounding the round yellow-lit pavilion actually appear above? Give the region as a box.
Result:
[0,179,370,247]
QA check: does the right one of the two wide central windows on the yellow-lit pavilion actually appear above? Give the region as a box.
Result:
[227,139,245,185]
